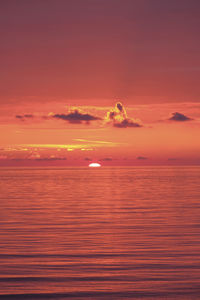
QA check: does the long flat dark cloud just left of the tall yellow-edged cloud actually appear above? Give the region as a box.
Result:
[52,108,101,124]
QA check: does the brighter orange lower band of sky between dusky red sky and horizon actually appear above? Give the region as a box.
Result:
[0,102,200,166]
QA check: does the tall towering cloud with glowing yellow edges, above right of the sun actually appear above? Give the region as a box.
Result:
[105,102,142,128]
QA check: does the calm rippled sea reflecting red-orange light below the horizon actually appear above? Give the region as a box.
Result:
[0,167,200,299]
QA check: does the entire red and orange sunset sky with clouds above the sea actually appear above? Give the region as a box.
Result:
[0,0,200,166]
